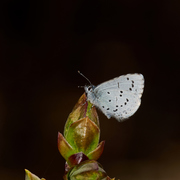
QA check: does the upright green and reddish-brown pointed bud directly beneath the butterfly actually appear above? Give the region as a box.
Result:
[58,94,104,167]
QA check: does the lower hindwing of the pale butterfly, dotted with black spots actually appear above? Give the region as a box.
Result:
[95,89,141,121]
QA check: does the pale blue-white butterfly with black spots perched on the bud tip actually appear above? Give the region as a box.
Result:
[85,74,144,121]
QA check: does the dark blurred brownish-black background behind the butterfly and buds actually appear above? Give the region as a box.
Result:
[0,0,180,180]
